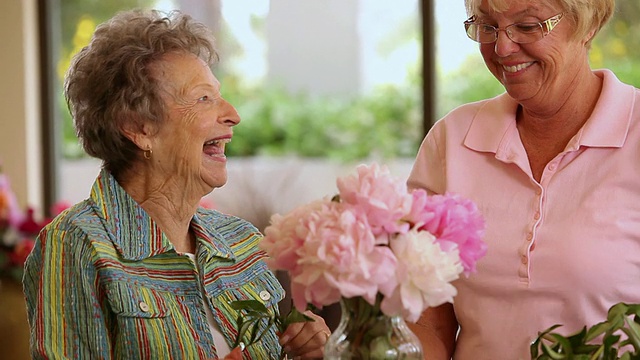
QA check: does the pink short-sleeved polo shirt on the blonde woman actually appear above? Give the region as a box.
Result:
[408,70,640,360]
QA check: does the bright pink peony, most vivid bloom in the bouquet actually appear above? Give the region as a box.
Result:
[407,189,487,275]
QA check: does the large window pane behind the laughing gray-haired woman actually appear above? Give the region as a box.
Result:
[49,0,423,210]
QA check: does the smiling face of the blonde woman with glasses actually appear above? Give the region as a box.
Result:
[476,0,588,107]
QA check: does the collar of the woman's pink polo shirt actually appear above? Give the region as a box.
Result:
[464,69,636,154]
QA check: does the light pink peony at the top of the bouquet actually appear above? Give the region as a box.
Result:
[337,164,412,236]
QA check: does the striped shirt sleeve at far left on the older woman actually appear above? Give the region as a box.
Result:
[23,221,111,359]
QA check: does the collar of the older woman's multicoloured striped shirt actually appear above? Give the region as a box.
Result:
[91,169,234,260]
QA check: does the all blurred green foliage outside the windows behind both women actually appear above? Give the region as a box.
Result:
[58,0,640,161]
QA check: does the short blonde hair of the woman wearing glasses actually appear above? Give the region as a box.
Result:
[464,0,616,44]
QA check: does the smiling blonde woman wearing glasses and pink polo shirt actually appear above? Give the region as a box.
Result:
[408,0,640,360]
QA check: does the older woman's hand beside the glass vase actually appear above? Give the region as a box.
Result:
[280,311,331,359]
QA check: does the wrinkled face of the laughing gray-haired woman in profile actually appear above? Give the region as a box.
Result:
[151,53,240,196]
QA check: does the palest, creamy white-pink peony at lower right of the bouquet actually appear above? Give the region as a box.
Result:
[381,229,463,322]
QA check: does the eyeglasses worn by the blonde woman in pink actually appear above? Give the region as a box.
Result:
[464,13,564,44]
